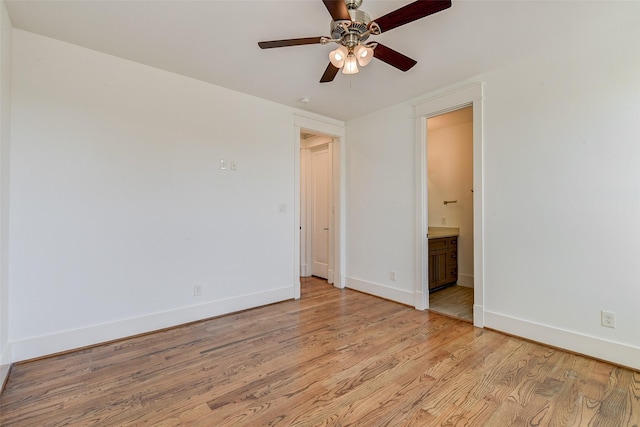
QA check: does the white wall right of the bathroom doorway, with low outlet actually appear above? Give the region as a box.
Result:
[483,13,640,368]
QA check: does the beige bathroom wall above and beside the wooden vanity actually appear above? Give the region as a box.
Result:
[427,118,473,288]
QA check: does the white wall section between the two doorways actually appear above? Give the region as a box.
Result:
[346,105,415,305]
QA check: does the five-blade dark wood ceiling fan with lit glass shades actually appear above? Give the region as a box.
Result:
[258,0,451,83]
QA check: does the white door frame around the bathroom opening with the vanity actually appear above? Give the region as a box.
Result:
[414,82,484,327]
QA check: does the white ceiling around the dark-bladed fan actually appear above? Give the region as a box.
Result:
[5,0,640,120]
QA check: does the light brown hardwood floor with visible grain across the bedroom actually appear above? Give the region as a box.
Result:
[0,278,640,427]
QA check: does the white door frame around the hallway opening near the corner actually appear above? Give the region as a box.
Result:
[293,114,346,299]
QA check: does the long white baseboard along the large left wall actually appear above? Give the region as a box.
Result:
[8,286,294,363]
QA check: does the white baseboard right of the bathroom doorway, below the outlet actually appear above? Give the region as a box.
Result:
[484,311,640,370]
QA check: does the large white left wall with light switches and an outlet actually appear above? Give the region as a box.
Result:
[9,30,342,360]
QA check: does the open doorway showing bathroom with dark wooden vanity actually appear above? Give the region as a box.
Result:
[426,106,474,322]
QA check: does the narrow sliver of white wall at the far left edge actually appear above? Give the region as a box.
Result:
[0,1,12,384]
